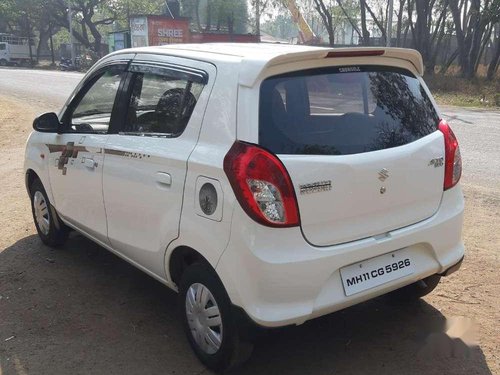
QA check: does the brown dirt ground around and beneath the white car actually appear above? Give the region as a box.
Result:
[0,96,500,375]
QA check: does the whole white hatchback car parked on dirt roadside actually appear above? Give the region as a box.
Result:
[25,44,464,370]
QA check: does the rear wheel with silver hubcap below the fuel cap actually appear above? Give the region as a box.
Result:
[179,263,253,371]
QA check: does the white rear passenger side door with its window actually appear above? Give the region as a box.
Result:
[103,55,215,277]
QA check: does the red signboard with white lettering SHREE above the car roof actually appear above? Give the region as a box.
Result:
[148,16,191,46]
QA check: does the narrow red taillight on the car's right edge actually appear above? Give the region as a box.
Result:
[439,120,462,190]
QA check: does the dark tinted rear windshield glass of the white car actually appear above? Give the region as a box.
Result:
[259,66,438,155]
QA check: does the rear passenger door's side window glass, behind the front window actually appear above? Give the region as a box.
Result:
[122,73,204,137]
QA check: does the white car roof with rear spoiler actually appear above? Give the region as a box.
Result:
[114,43,424,86]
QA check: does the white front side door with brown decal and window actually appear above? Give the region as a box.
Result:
[47,65,126,243]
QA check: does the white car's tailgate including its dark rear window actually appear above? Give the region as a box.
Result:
[259,66,444,246]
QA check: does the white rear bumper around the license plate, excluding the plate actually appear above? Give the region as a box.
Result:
[216,186,464,327]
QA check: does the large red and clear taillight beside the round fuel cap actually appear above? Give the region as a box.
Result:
[224,141,299,227]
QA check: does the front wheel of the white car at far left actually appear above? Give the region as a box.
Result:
[30,178,69,247]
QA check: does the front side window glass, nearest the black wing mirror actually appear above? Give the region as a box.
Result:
[68,68,125,133]
